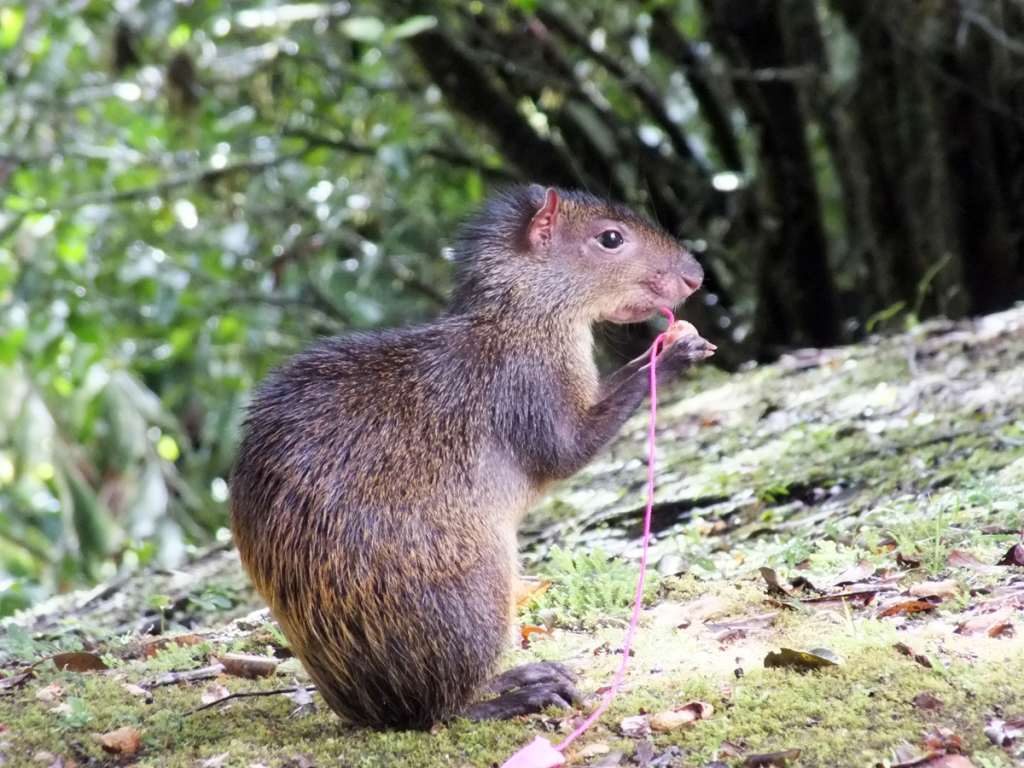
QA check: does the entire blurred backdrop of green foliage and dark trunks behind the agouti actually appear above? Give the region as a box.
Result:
[0,0,1024,615]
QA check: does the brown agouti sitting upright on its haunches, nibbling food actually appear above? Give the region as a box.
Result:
[231,186,714,728]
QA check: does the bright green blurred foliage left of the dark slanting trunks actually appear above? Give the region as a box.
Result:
[0,0,499,615]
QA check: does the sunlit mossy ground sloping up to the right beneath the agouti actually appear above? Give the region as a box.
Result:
[0,310,1024,768]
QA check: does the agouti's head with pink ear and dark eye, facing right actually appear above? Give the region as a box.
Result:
[452,185,703,323]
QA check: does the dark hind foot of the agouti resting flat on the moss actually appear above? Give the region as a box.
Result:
[464,662,580,720]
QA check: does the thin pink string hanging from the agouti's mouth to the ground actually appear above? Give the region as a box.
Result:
[502,307,676,768]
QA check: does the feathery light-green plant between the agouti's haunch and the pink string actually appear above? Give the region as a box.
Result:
[523,547,657,628]
